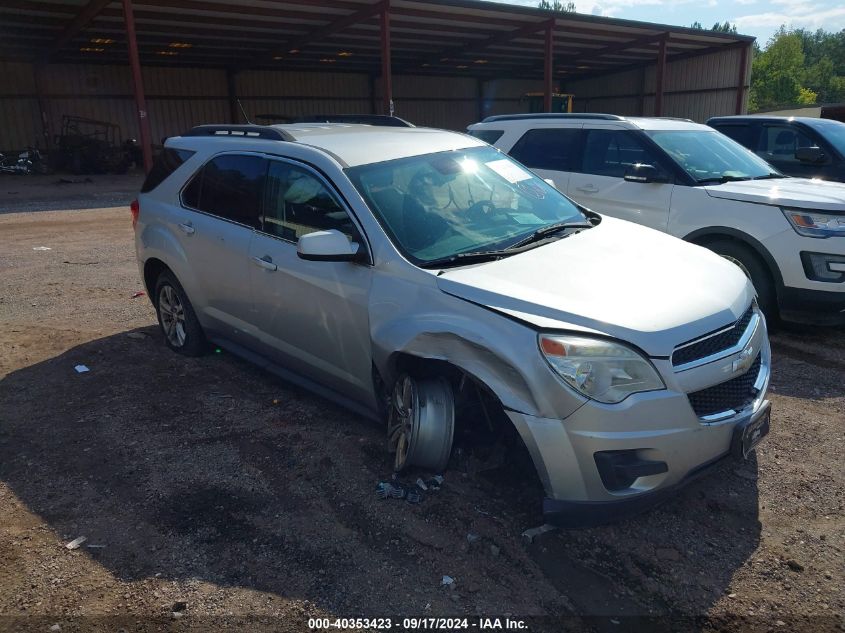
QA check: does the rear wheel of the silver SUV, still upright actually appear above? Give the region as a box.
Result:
[155,270,207,356]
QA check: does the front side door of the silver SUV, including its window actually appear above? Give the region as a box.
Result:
[249,159,372,401]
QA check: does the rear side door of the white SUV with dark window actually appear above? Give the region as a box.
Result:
[508,123,583,193]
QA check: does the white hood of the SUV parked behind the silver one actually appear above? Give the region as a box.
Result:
[704,178,845,211]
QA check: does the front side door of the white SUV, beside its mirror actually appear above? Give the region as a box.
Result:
[566,125,674,231]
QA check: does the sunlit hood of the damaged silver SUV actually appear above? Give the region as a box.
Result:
[437,216,754,357]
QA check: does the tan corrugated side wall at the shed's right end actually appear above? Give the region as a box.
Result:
[566,48,751,122]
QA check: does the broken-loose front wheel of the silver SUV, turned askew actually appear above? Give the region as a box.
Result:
[387,374,455,473]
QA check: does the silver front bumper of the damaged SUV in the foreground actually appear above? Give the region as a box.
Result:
[508,323,771,526]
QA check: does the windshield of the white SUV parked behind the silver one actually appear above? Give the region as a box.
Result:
[648,130,782,183]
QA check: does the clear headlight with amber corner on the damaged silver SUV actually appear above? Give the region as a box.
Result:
[539,334,666,404]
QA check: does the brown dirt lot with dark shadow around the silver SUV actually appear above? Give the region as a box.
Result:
[0,189,845,632]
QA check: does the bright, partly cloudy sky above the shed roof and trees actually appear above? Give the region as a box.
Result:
[488,0,845,47]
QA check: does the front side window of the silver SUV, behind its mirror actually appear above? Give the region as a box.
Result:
[264,161,360,242]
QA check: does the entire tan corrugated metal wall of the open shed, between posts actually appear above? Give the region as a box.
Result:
[0,49,750,149]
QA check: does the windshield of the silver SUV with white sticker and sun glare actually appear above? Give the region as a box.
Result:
[346,147,586,266]
